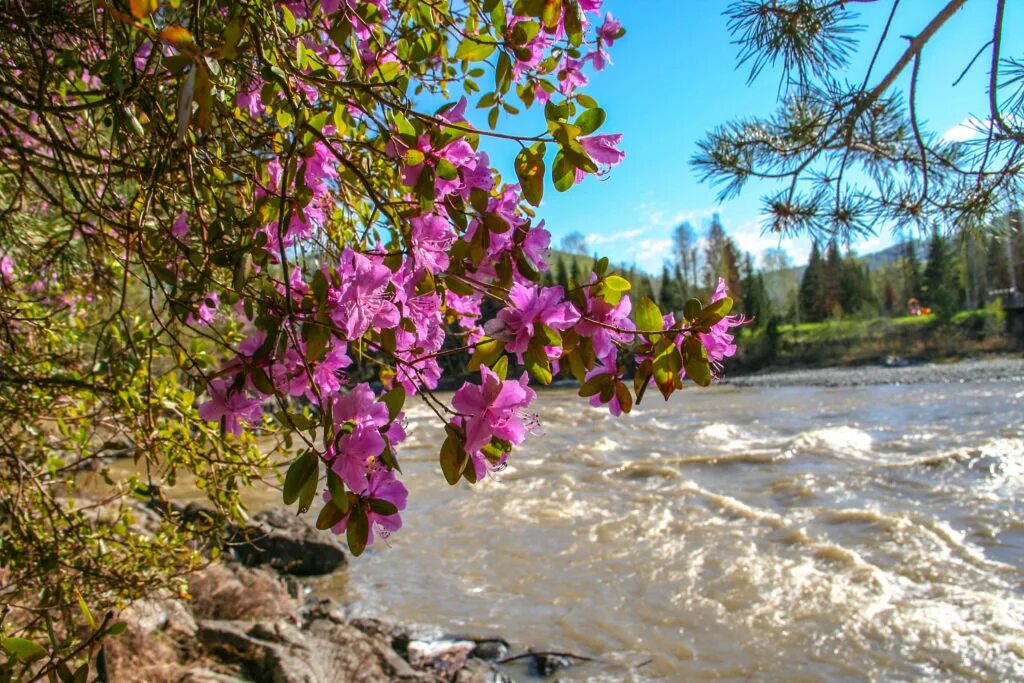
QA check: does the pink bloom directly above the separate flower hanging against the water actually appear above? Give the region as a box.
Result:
[484,285,580,362]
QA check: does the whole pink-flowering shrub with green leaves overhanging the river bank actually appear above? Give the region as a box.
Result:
[0,0,741,679]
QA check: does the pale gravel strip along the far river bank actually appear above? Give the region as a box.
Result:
[725,356,1024,387]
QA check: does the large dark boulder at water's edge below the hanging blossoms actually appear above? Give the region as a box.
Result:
[232,508,345,577]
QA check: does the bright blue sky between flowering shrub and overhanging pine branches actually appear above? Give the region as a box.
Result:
[475,0,1024,270]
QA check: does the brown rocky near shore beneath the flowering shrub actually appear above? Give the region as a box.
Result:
[106,506,589,683]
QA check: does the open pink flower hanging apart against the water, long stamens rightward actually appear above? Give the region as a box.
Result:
[452,366,537,453]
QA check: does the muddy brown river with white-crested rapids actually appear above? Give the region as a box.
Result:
[316,378,1024,681]
